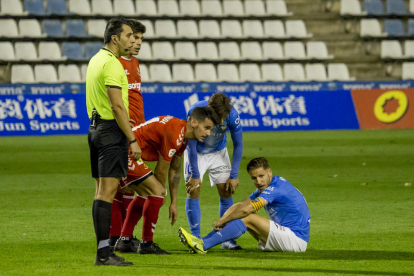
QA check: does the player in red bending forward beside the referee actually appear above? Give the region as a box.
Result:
[115,107,219,255]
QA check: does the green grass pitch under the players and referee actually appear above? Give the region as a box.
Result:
[0,130,414,275]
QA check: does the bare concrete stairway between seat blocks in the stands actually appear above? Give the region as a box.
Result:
[286,0,401,81]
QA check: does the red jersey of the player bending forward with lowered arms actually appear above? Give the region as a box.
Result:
[132,116,188,162]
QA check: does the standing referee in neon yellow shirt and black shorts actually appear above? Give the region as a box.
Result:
[86,17,141,266]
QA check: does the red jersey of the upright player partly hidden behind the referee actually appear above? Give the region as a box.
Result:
[119,57,145,125]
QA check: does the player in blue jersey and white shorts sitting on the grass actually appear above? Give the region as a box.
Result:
[178,157,310,254]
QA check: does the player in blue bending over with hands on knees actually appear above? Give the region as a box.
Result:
[184,93,243,250]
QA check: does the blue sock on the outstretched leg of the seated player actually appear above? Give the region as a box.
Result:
[203,219,247,250]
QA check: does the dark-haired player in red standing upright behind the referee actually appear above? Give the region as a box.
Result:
[109,19,146,247]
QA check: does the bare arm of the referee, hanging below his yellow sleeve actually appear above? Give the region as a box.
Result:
[106,87,141,160]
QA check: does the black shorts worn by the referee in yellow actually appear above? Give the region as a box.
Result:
[88,119,128,178]
